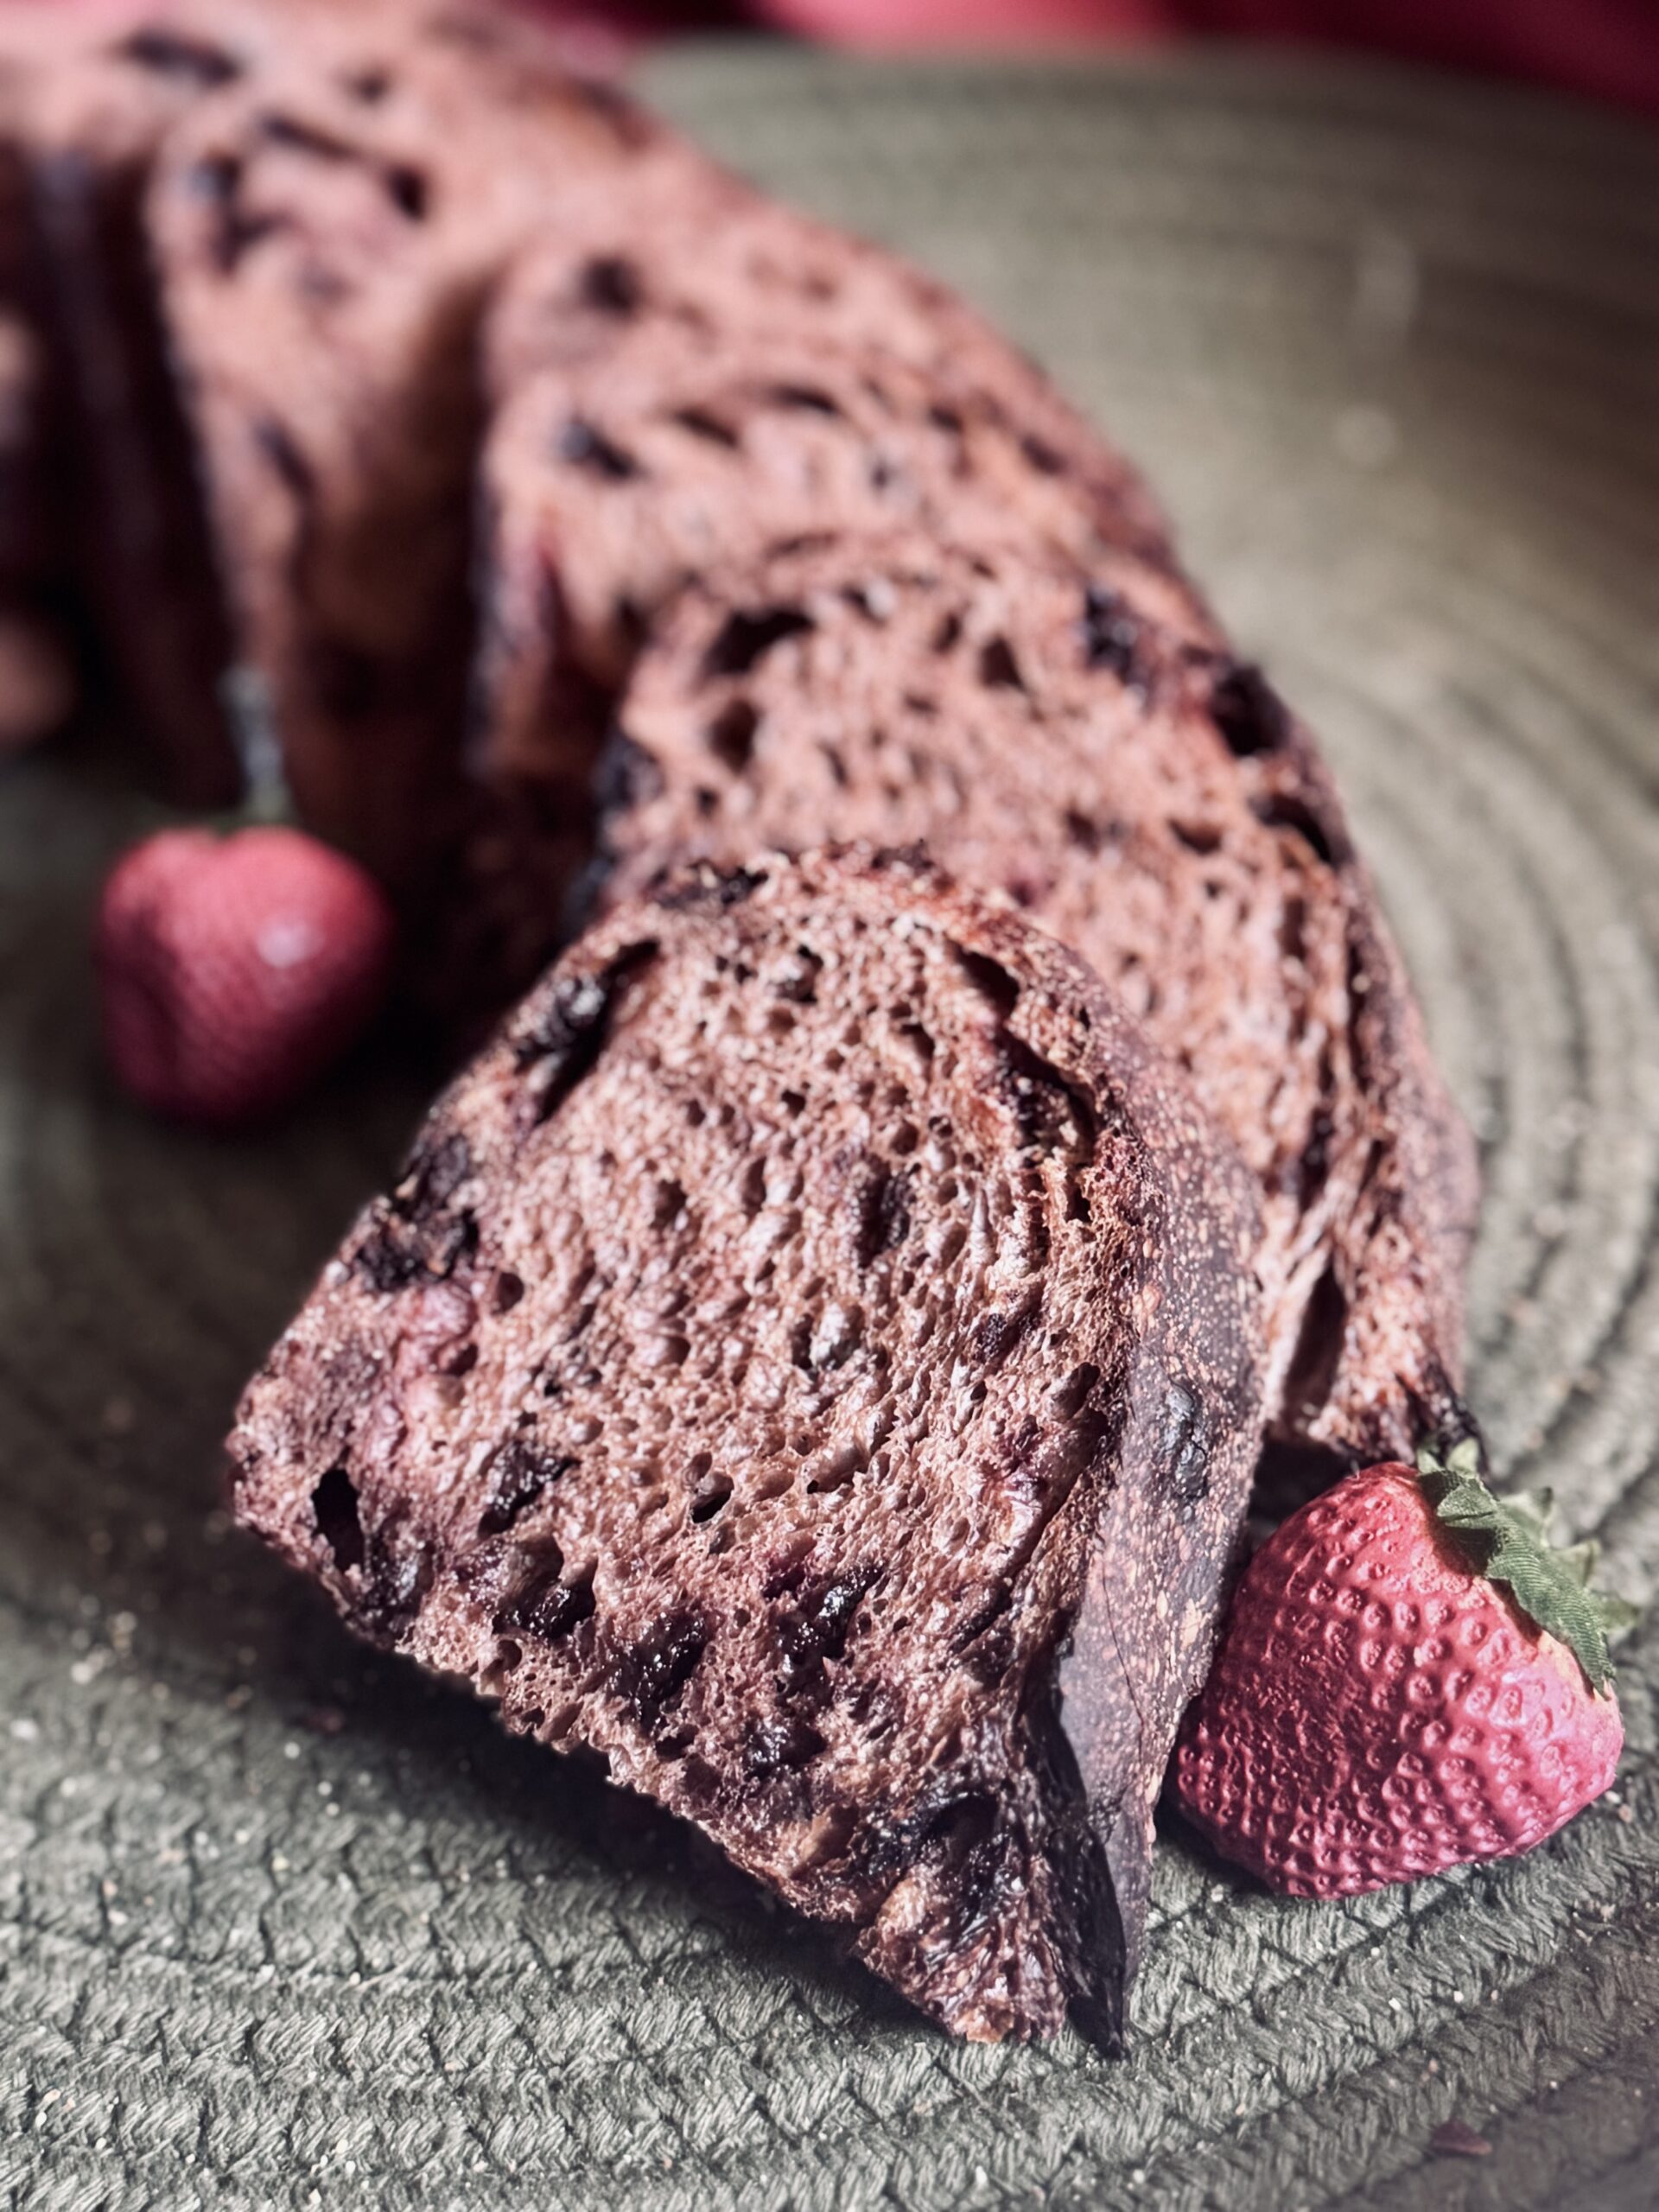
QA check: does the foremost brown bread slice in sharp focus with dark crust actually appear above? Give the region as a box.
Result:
[230,854,1259,2044]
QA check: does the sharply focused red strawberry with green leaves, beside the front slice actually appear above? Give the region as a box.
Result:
[1174,1445,1626,1897]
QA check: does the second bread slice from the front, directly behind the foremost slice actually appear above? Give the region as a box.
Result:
[600,536,1476,1460]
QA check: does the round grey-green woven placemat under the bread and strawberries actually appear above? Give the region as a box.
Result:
[0,48,1659,2212]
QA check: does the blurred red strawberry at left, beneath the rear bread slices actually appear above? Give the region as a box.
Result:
[98,827,391,1128]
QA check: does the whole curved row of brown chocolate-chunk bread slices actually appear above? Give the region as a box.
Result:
[0,0,1476,2046]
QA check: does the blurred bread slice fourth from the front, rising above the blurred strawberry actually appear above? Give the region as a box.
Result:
[149,7,690,898]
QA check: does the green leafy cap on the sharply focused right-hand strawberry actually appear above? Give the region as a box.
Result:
[1418,1438,1637,1692]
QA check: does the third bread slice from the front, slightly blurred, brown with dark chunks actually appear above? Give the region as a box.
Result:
[475,181,1173,804]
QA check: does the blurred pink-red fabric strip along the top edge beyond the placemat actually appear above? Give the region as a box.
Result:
[555,0,1659,113]
